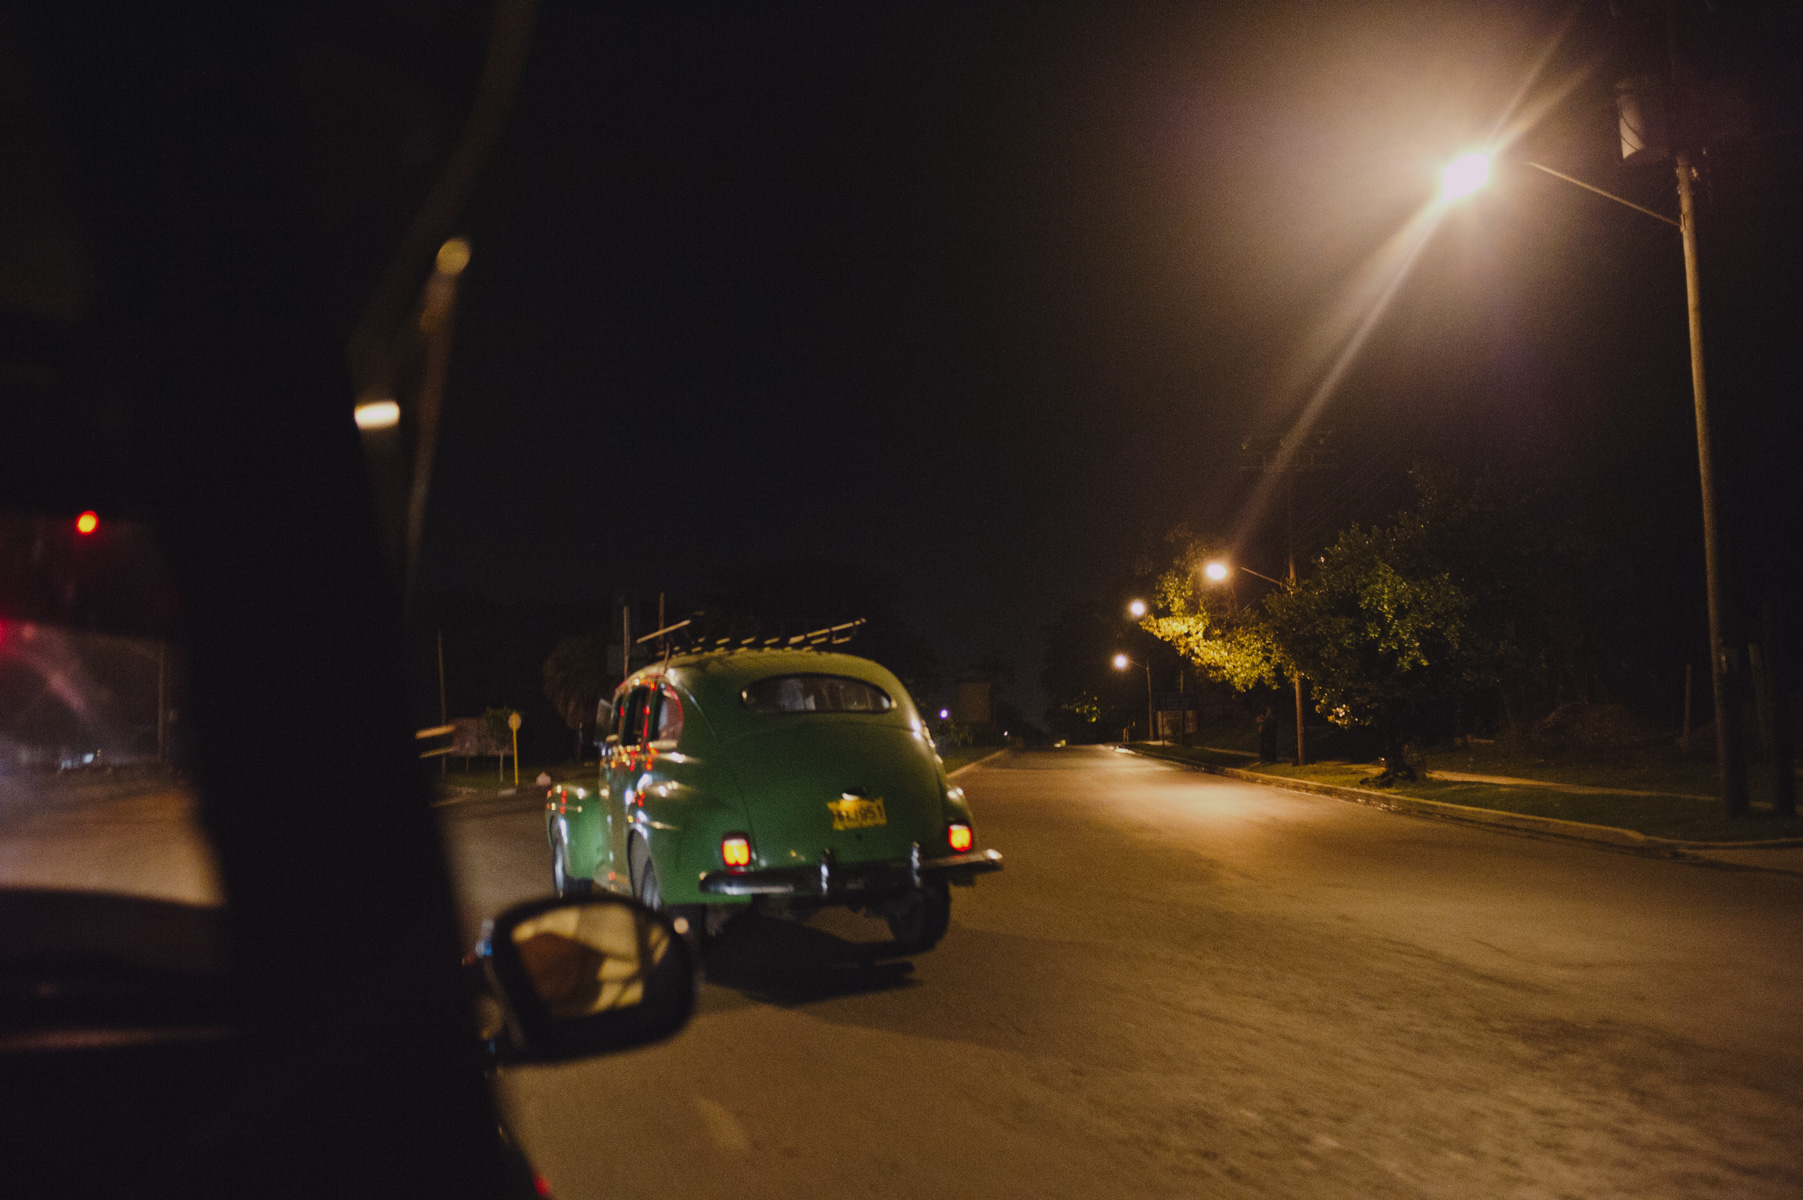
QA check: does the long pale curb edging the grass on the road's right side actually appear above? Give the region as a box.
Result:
[1127,746,1803,874]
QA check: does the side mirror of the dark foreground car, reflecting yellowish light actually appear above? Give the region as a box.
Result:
[476,895,694,1063]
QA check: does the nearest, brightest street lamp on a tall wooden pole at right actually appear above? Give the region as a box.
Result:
[1441,150,1747,816]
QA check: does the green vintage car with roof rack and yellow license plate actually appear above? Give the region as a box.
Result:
[545,649,1002,951]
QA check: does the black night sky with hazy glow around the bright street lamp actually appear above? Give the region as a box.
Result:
[424,2,1803,709]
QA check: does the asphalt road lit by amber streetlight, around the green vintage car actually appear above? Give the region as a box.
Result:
[444,748,1803,1200]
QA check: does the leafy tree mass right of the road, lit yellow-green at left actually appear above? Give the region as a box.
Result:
[1143,467,1700,775]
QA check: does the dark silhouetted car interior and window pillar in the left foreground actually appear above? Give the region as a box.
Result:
[0,0,691,1196]
